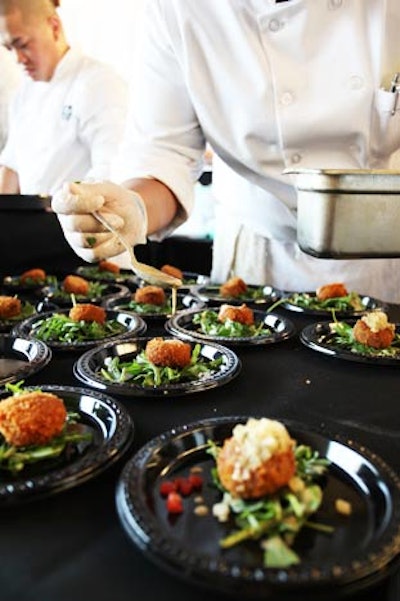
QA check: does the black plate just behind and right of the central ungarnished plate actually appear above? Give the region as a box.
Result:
[165,308,296,346]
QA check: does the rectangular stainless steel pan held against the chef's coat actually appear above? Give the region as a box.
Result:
[285,169,400,259]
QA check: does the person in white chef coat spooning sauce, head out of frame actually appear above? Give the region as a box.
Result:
[53,0,400,302]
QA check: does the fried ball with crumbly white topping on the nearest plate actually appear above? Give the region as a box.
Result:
[217,418,296,499]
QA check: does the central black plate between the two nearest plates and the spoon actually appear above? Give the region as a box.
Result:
[74,338,241,397]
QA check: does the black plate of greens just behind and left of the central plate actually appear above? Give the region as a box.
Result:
[12,309,147,351]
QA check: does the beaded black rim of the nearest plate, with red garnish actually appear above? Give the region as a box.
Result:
[115,415,400,599]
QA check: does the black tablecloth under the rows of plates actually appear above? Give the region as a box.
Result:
[0,214,400,601]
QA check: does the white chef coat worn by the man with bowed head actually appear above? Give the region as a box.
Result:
[0,49,128,195]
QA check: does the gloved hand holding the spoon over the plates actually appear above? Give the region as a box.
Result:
[51,181,147,263]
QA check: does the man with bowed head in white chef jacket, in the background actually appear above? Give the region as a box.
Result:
[0,0,128,195]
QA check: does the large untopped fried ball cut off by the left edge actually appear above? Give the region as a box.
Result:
[0,390,67,447]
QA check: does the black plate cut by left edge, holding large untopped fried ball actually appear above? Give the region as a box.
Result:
[0,385,133,506]
